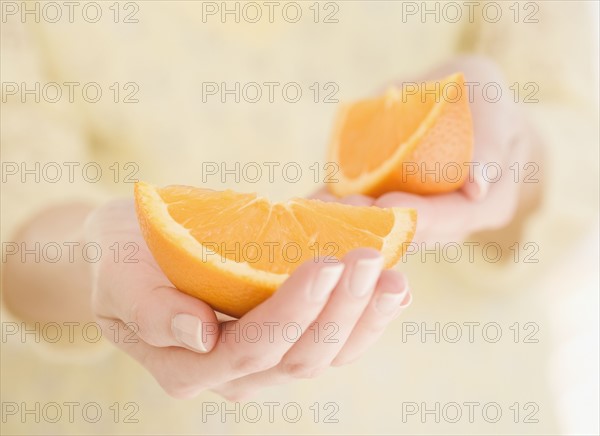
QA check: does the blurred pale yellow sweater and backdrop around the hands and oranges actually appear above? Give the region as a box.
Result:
[0,1,599,434]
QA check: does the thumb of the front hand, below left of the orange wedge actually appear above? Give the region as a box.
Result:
[90,205,218,352]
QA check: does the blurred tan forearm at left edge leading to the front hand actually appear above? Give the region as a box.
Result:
[2,203,95,322]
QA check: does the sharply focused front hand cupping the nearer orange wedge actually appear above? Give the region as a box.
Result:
[86,200,411,400]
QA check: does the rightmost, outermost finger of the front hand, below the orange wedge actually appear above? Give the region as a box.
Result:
[332,270,412,366]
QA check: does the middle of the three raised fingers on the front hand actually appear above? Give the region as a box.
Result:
[217,248,383,398]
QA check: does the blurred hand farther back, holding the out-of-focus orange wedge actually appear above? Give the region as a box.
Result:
[314,57,535,243]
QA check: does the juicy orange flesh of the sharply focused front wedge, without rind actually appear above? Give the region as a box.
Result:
[158,186,394,273]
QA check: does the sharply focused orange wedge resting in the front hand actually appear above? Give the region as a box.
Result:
[135,182,416,317]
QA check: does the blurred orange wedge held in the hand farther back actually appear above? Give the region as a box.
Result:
[328,73,473,196]
